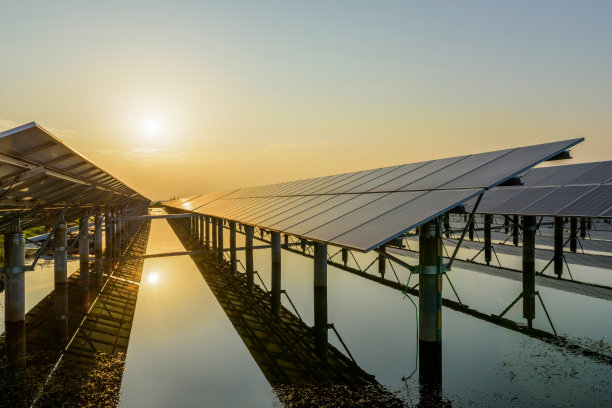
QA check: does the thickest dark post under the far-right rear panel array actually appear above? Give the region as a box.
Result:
[523,215,536,329]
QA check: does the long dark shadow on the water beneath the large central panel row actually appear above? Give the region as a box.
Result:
[168,220,449,407]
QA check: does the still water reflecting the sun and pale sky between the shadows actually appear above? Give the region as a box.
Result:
[121,220,612,407]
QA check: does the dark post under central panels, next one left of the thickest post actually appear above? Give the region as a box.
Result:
[314,242,327,363]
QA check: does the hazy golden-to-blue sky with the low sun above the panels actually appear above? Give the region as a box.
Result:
[0,0,612,199]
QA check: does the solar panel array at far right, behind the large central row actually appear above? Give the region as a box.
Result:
[466,161,612,217]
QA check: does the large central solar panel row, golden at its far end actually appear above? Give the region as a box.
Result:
[164,139,583,251]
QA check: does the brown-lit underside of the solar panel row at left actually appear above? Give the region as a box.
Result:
[0,122,149,231]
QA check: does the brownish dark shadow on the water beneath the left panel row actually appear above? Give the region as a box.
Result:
[0,221,150,407]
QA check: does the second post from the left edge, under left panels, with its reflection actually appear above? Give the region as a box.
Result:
[53,218,68,347]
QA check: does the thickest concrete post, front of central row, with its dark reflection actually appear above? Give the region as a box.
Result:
[419,220,442,392]
